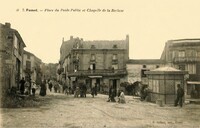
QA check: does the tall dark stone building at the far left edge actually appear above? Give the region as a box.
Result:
[0,23,26,94]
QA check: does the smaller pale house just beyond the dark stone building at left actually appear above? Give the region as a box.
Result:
[23,51,43,84]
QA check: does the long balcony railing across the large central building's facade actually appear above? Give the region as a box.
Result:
[69,69,127,76]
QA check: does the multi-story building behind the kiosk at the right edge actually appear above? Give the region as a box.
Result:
[161,39,200,98]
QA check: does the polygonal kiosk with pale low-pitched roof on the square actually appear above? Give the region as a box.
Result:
[145,67,187,104]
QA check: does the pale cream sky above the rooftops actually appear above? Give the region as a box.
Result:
[0,0,200,63]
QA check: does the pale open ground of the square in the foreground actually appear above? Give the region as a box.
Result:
[1,93,200,128]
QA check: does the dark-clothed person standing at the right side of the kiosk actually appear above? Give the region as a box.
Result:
[174,84,184,107]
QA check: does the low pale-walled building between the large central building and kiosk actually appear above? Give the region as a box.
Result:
[126,59,164,85]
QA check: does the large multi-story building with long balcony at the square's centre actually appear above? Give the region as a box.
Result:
[58,35,129,93]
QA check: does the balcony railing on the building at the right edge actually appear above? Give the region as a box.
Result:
[174,57,200,63]
